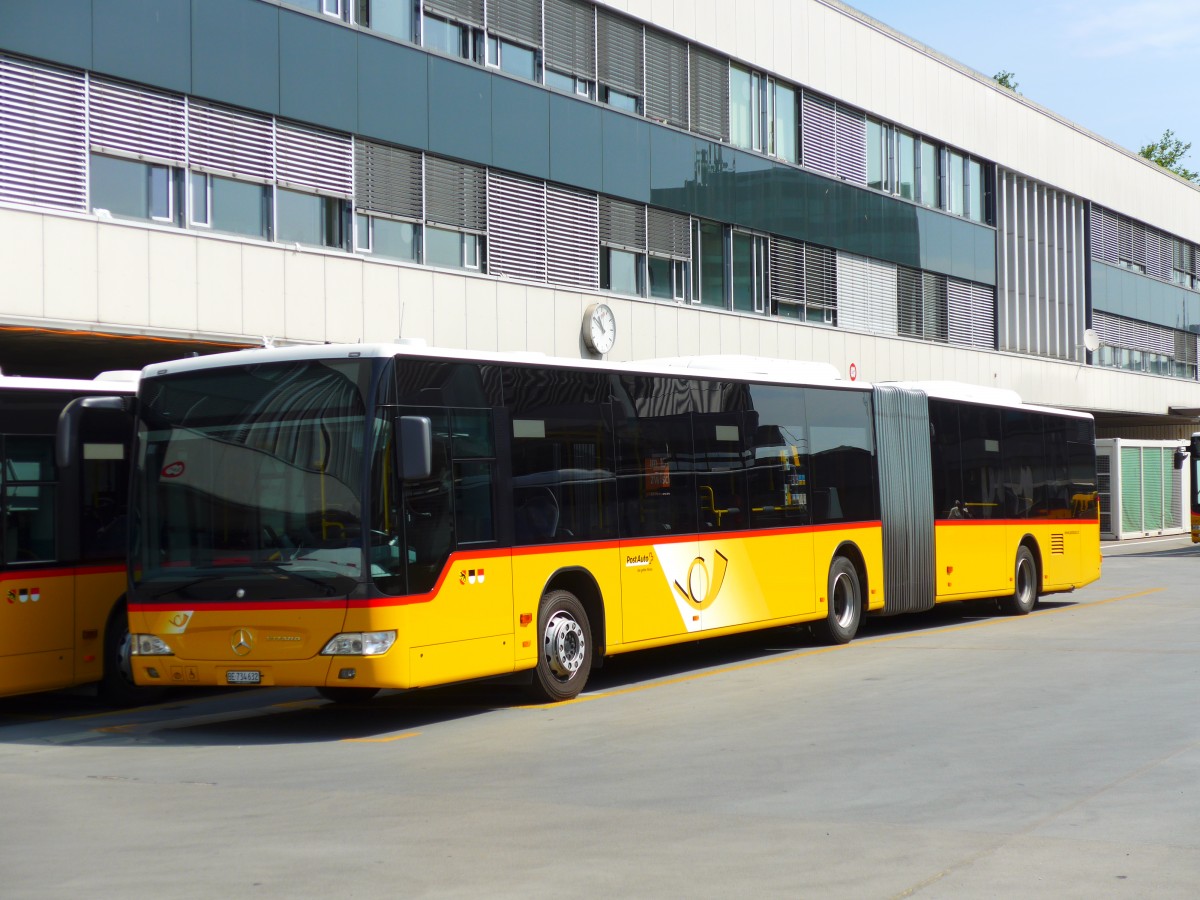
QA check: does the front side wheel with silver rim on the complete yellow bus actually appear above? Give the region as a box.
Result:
[529,590,592,703]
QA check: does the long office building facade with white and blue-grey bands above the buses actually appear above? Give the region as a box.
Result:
[0,0,1200,438]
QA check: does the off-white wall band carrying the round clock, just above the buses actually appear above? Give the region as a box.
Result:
[9,206,1200,415]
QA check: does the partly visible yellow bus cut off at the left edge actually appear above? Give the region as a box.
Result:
[0,372,156,703]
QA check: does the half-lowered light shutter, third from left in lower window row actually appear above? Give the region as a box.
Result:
[187,102,275,181]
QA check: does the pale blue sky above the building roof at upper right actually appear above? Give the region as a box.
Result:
[845,0,1200,162]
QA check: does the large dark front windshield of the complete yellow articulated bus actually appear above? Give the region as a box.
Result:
[132,359,370,602]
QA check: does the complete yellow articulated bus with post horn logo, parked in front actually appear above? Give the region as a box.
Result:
[119,344,1100,701]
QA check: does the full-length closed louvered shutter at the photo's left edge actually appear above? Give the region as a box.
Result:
[0,56,88,210]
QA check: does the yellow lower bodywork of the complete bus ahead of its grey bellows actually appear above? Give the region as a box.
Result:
[130,522,884,689]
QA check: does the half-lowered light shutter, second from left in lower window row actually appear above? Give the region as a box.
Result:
[88,78,187,166]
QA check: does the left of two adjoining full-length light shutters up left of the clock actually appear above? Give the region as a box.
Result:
[487,169,546,282]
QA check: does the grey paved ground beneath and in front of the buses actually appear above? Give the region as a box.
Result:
[0,539,1200,899]
